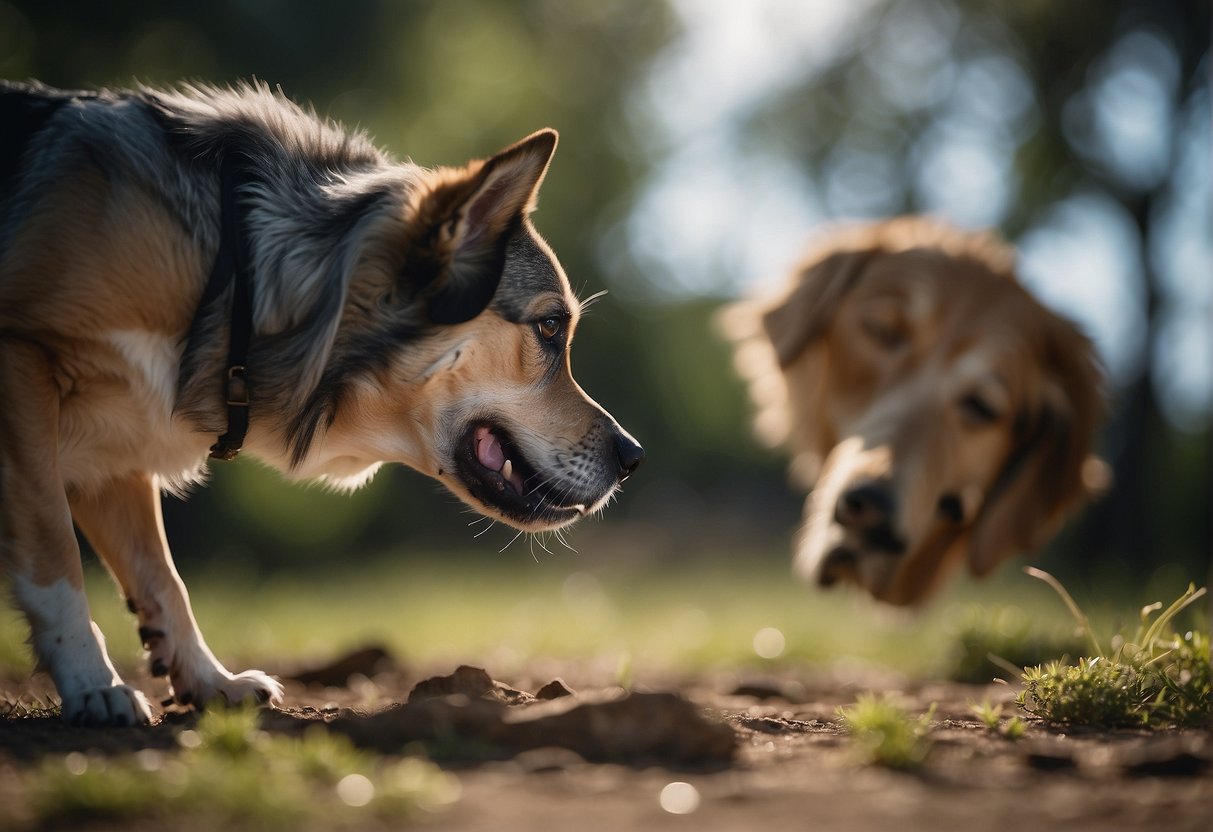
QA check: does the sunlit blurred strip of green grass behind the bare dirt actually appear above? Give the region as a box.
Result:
[0,553,1193,686]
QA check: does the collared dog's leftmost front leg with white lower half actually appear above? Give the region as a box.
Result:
[0,337,152,725]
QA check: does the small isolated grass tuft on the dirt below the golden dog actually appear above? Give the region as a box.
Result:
[838,694,935,771]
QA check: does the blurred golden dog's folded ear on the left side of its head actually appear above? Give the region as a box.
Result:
[762,250,873,367]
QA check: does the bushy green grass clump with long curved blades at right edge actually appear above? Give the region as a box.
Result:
[1015,568,1213,728]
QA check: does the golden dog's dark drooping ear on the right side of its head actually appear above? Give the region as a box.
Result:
[969,313,1107,577]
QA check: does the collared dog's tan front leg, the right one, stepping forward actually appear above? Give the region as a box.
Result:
[72,473,283,706]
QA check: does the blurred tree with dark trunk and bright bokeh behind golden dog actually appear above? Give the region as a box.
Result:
[748,0,1211,576]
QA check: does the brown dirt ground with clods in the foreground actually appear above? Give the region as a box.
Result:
[0,651,1213,832]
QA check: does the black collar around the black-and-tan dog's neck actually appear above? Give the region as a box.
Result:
[193,150,252,460]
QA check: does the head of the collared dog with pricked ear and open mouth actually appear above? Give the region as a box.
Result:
[278,130,644,531]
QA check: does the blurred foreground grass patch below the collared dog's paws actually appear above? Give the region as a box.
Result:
[25,708,457,830]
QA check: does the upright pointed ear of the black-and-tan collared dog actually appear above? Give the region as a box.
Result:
[409,129,557,324]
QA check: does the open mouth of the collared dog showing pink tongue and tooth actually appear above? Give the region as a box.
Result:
[455,422,586,526]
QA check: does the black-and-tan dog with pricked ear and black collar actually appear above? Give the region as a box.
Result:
[0,84,643,724]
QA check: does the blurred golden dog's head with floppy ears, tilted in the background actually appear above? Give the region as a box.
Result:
[724,217,1105,604]
